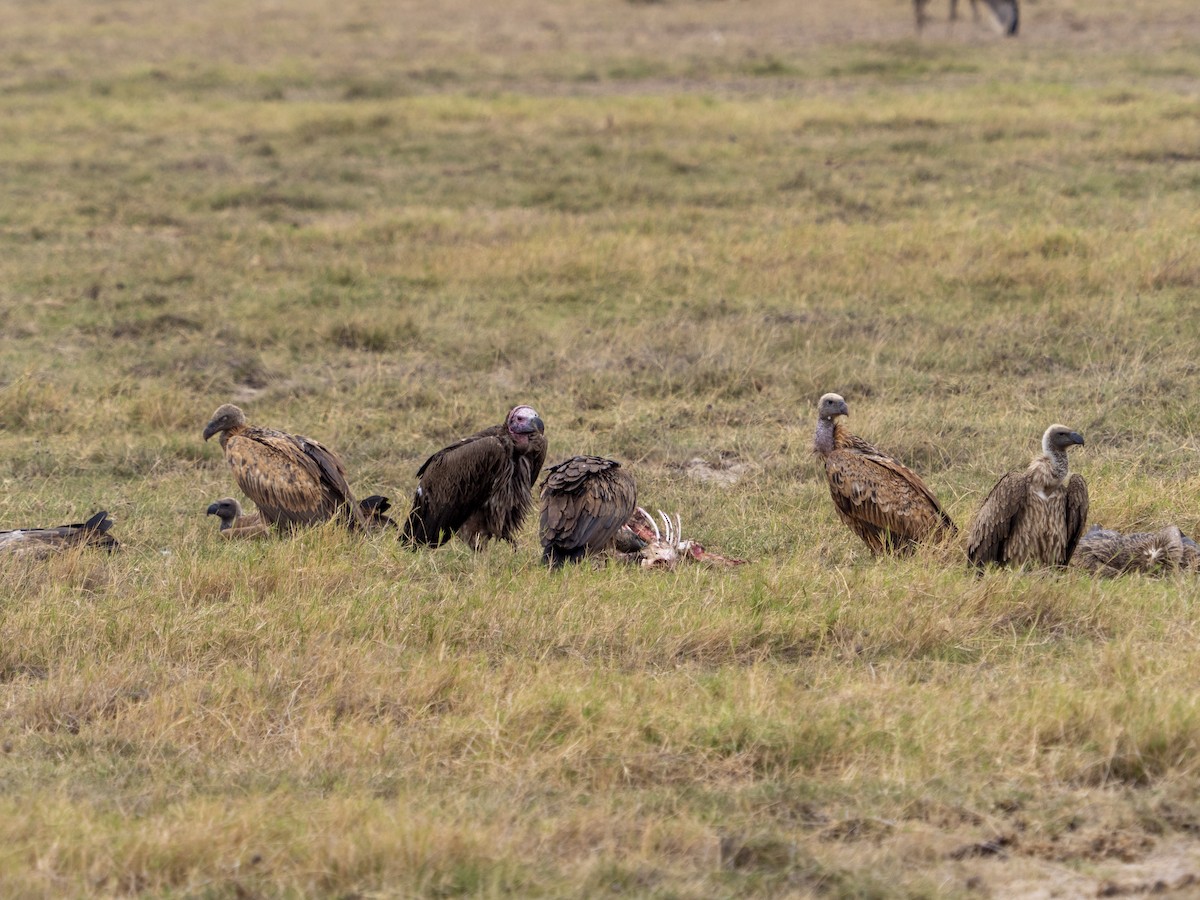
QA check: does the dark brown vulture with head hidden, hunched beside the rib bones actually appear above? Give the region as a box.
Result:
[540,456,637,569]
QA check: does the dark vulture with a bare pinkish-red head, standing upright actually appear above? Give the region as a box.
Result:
[401,407,546,550]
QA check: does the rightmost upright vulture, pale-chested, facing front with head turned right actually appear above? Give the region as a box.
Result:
[967,425,1087,566]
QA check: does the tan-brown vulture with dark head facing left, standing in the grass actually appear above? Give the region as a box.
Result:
[204,403,364,528]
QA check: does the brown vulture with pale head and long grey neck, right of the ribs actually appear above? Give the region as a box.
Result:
[812,394,958,554]
